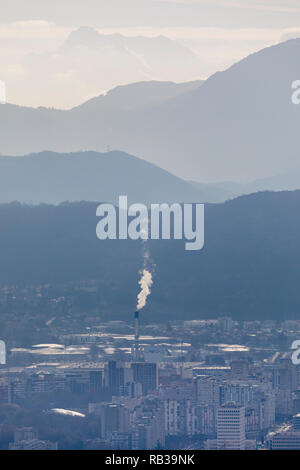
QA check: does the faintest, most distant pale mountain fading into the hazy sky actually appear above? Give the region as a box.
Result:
[5,27,206,109]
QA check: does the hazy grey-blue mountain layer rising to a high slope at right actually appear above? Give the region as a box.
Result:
[0,39,300,183]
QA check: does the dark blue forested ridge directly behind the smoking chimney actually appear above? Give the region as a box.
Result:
[0,191,300,321]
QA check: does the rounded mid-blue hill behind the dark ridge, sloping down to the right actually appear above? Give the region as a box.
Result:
[0,151,204,204]
